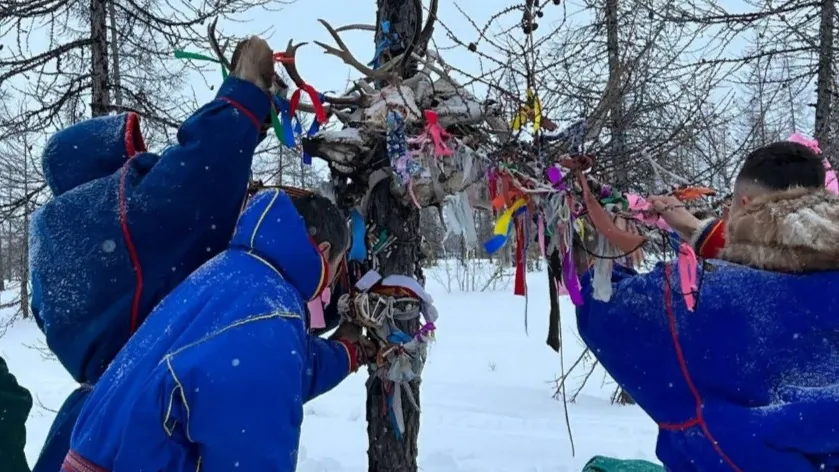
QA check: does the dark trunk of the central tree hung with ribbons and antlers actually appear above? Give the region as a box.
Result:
[367,0,425,472]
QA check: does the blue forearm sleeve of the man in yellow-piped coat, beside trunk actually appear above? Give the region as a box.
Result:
[306,335,357,401]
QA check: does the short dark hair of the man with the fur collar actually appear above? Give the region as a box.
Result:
[737,141,825,190]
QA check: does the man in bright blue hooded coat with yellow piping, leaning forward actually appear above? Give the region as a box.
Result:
[61,189,375,472]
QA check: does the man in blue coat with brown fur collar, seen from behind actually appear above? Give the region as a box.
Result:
[577,142,839,472]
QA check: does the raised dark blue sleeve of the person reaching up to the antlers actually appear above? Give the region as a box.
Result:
[125,77,270,239]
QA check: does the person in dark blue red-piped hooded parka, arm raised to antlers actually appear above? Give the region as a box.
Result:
[30,38,273,472]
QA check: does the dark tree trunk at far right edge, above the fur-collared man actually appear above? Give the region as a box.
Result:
[814,0,836,156]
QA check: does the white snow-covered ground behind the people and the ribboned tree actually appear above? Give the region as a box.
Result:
[0,271,656,472]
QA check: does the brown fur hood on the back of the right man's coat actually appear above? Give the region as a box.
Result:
[720,188,839,273]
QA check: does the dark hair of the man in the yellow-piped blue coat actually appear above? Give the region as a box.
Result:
[289,194,350,261]
